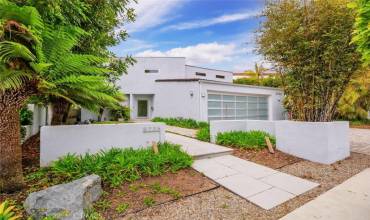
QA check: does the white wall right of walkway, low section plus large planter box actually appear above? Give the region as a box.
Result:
[210,120,350,164]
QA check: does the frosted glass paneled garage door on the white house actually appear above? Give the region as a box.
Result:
[208,94,268,121]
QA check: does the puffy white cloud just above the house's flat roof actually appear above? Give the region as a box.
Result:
[136,42,237,65]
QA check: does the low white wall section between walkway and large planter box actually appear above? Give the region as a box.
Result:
[210,120,275,143]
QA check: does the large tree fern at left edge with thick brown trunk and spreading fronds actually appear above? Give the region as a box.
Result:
[0,0,122,192]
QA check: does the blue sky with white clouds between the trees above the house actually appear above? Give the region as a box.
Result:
[111,0,264,71]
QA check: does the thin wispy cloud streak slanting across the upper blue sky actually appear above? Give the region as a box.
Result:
[162,11,260,31]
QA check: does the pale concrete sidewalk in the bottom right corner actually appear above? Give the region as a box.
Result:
[281,168,370,220]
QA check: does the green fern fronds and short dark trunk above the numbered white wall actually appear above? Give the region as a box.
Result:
[35,27,124,125]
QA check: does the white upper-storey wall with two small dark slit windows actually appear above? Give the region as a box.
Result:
[185,65,233,83]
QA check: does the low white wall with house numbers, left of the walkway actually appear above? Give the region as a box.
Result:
[40,123,165,166]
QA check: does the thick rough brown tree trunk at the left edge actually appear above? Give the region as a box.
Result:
[0,81,37,192]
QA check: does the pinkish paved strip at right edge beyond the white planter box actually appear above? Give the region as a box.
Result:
[350,128,370,156]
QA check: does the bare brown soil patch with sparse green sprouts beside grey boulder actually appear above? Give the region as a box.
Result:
[95,168,218,219]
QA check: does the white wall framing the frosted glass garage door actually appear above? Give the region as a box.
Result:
[200,81,284,121]
